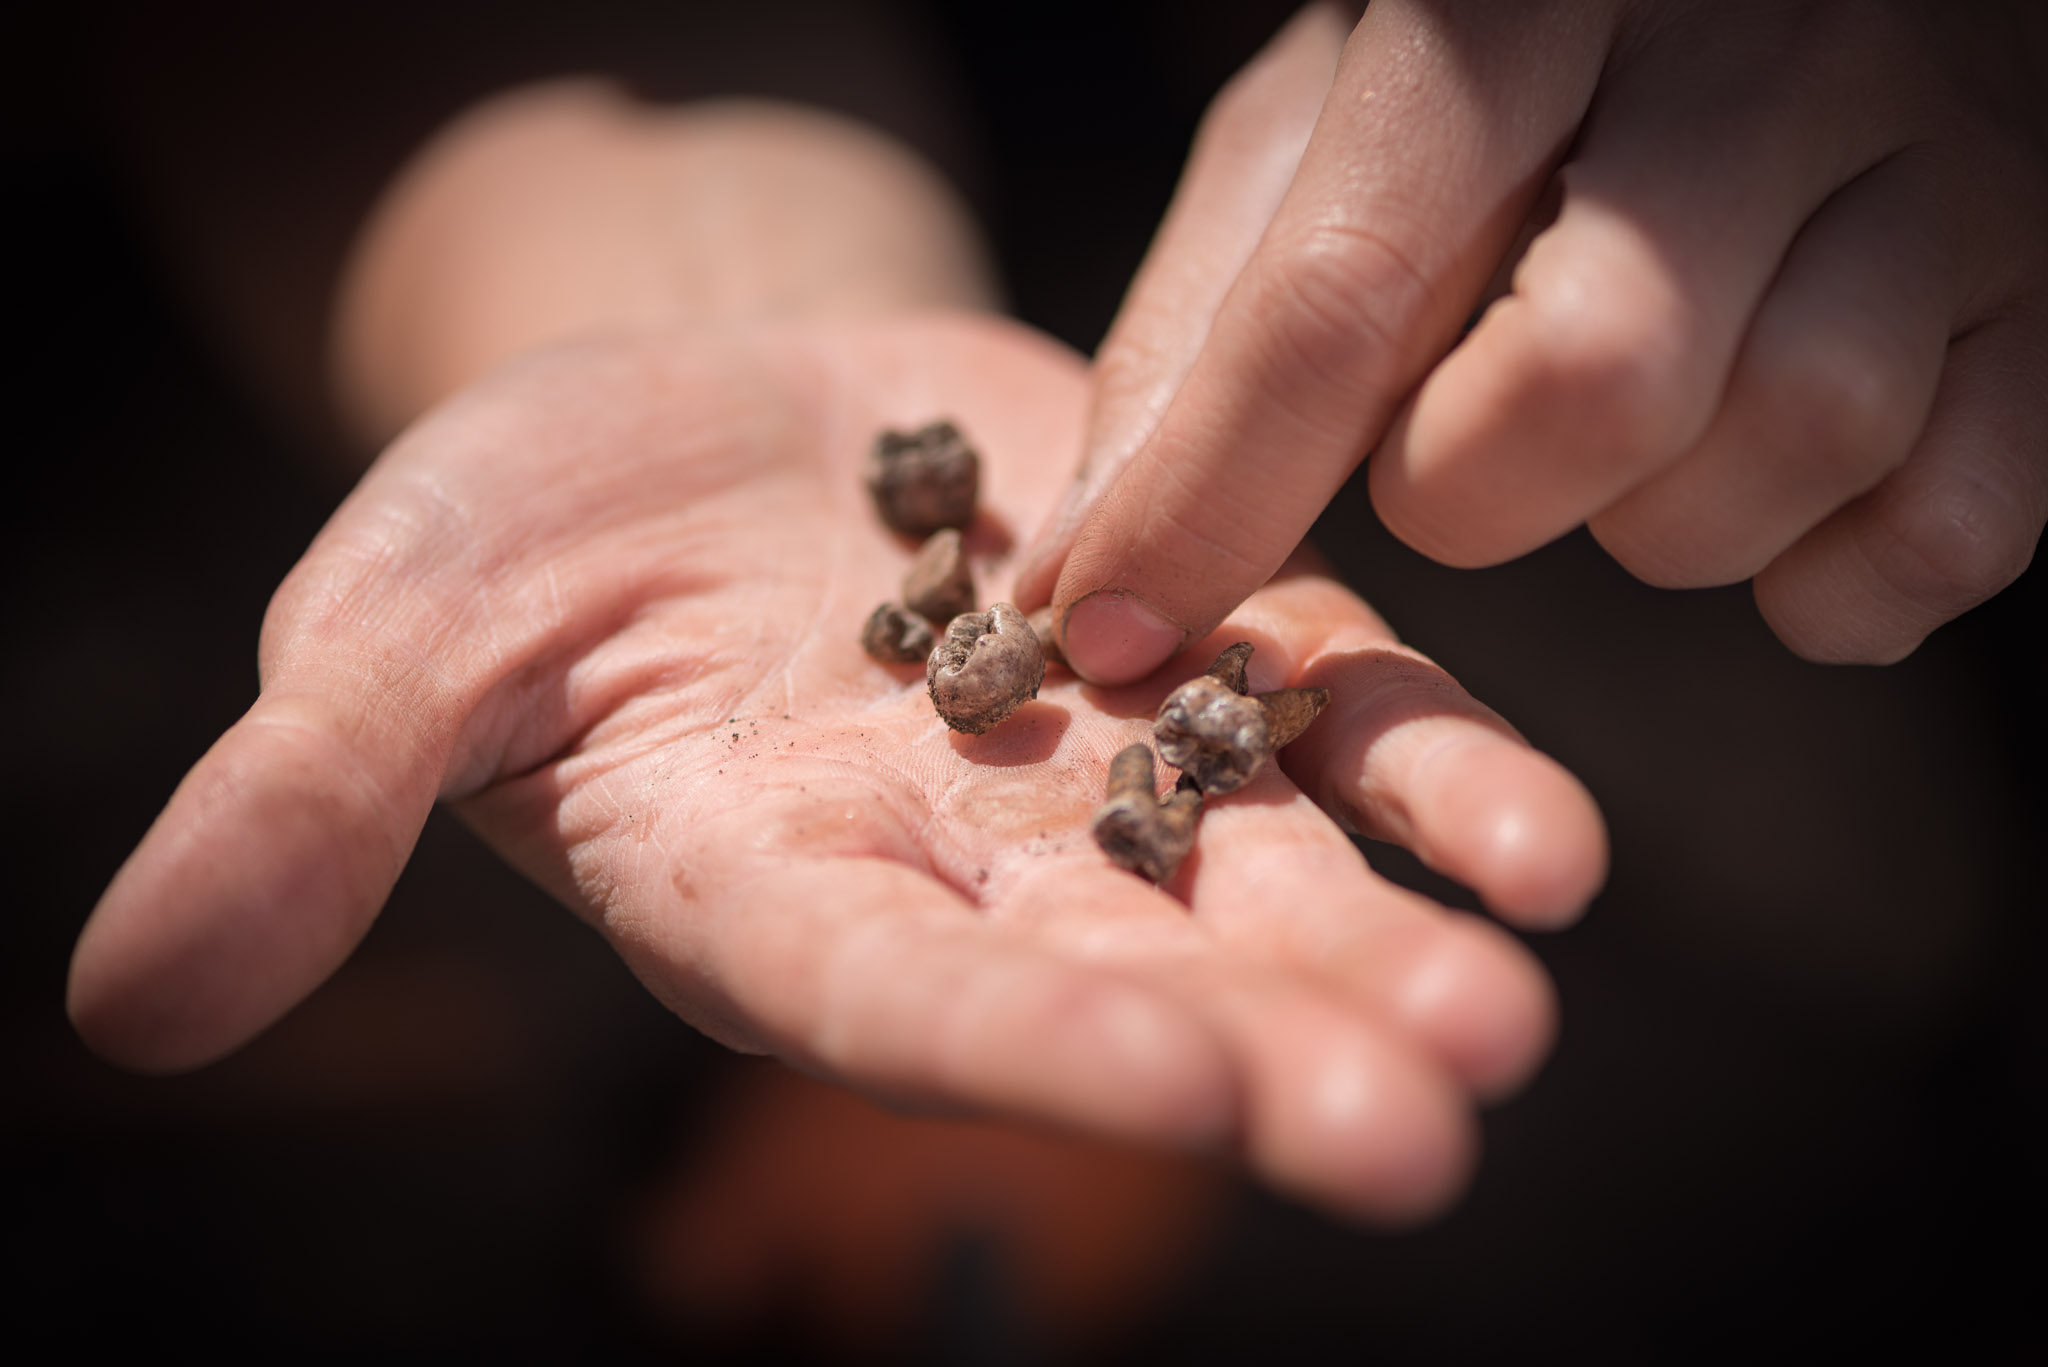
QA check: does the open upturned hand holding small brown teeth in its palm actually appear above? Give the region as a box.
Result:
[70,318,1604,1217]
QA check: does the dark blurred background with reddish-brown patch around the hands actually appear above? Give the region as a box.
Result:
[0,0,2048,1363]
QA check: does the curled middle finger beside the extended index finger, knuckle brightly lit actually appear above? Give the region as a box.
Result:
[1370,6,1909,566]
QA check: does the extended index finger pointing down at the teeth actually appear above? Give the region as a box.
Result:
[1053,0,1616,682]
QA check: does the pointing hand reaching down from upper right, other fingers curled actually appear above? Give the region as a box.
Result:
[1018,0,2048,682]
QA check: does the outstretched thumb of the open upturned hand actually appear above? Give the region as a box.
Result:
[68,656,459,1072]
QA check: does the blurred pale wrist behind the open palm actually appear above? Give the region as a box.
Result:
[328,82,997,443]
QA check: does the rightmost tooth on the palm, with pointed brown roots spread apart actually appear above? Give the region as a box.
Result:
[1153,641,1329,793]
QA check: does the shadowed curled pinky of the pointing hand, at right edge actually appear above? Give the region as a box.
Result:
[1755,315,2048,664]
